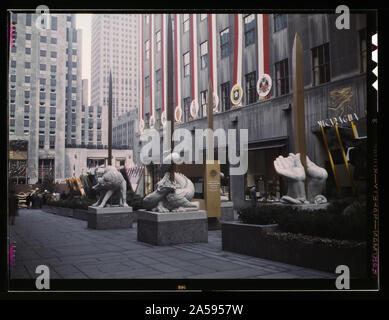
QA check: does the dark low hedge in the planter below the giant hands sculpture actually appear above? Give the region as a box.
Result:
[238,199,366,241]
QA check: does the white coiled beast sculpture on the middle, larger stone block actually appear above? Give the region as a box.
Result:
[143,153,200,212]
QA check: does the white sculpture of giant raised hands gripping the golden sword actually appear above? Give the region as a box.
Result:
[274,153,328,204]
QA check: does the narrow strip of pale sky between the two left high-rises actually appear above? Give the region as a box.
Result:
[76,13,92,105]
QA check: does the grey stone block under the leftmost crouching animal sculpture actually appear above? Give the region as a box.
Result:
[88,206,132,230]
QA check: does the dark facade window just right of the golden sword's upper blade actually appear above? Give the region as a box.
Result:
[312,43,330,85]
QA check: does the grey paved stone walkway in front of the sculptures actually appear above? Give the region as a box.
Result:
[10,209,335,279]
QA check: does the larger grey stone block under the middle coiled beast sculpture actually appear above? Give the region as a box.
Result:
[138,210,208,246]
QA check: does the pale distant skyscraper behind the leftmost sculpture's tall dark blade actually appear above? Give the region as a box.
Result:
[91,14,139,120]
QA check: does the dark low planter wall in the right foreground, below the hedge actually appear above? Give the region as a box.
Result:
[222,222,367,278]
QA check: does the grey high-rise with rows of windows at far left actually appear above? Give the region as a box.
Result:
[9,13,81,183]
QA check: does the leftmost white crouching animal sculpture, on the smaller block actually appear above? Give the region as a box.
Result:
[92,166,128,208]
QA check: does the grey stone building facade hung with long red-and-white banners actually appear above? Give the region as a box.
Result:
[134,14,367,206]
